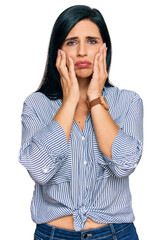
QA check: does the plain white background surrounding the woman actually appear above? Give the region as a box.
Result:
[0,0,162,240]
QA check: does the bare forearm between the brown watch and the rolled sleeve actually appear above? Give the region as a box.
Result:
[91,104,120,158]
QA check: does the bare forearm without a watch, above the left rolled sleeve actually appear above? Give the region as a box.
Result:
[53,102,76,142]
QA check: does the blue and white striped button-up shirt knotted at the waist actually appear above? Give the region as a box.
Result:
[19,87,143,231]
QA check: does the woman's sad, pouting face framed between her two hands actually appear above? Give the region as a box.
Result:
[61,19,103,78]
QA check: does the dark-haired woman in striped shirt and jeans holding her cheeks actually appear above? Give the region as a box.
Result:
[19,5,143,240]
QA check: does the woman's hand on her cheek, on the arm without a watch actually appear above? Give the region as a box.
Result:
[56,49,80,105]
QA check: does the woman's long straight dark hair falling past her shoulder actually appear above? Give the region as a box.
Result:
[37,5,112,100]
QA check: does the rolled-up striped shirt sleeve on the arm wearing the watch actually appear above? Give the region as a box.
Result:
[103,94,143,177]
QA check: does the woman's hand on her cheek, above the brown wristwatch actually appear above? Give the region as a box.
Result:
[87,44,108,101]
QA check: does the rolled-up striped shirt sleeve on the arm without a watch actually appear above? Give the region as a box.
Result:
[19,103,68,185]
